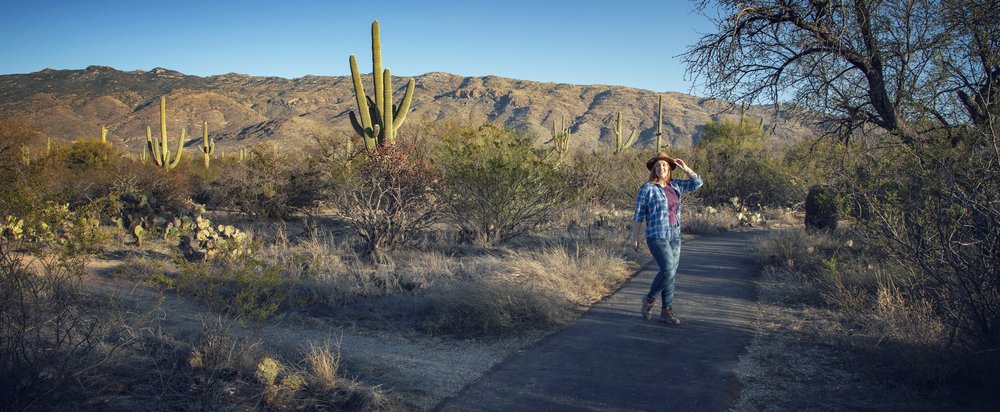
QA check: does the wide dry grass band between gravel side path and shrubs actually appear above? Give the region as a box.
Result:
[242,214,630,338]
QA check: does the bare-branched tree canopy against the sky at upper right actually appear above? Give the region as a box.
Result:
[685,0,1000,143]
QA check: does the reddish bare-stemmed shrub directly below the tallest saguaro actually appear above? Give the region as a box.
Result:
[333,144,440,261]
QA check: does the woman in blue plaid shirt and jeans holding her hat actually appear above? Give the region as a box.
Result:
[631,152,703,325]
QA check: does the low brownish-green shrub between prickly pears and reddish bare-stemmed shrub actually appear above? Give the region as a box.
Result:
[194,144,333,219]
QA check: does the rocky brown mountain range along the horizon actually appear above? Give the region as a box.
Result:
[0,66,814,150]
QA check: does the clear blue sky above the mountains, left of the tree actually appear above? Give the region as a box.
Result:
[0,0,712,94]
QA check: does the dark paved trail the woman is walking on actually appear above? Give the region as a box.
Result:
[438,232,762,412]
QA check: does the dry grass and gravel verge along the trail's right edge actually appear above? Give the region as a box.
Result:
[736,230,996,410]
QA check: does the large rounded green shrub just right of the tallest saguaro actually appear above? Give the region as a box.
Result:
[438,125,574,245]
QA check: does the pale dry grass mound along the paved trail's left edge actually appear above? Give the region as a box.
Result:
[422,247,629,338]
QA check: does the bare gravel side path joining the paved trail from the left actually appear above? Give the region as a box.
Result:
[85,260,543,411]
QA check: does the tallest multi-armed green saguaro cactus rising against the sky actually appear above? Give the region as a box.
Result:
[350,20,414,150]
